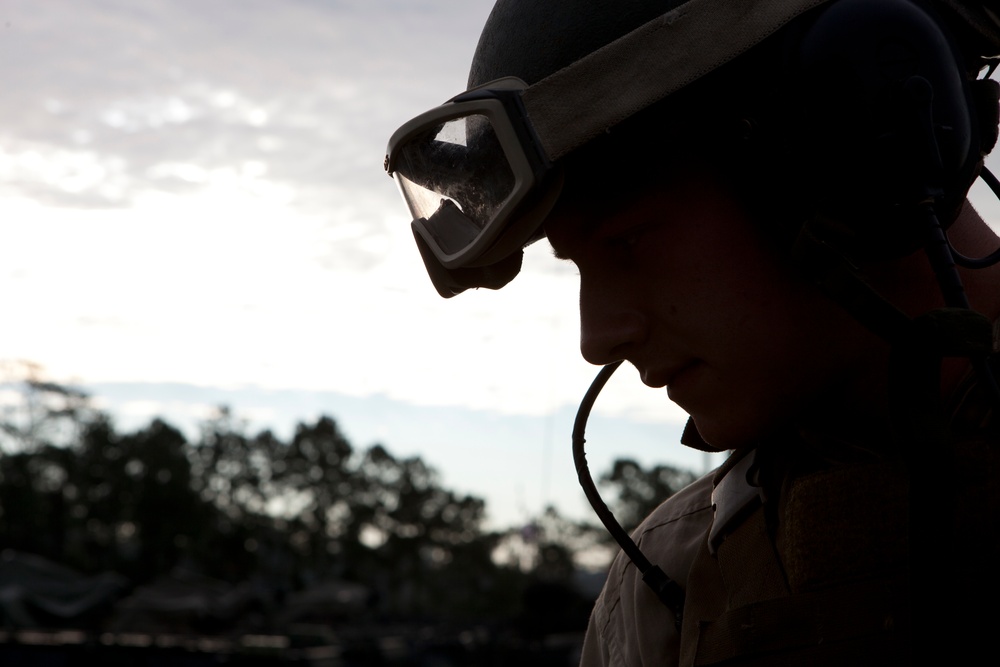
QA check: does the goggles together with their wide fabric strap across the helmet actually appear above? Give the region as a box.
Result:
[385,0,825,297]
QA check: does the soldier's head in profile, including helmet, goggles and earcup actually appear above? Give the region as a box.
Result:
[386,0,995,447]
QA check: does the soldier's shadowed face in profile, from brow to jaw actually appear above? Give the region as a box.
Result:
[546,170,885,448]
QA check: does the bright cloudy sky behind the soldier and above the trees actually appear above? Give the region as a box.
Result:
[0,0,1000,525]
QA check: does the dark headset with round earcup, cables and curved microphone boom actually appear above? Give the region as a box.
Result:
[573,0,1000,627]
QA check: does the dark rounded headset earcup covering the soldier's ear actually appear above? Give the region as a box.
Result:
[788,0,980,261]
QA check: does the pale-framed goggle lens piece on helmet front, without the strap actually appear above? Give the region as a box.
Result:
[385,78,559,288]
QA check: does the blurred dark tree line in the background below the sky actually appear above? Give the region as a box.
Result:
[0,370,693,632]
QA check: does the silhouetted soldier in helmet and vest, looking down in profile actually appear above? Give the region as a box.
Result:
[386,0,1000,665]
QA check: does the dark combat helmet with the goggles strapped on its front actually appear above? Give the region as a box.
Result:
[385,0,1000,297]
